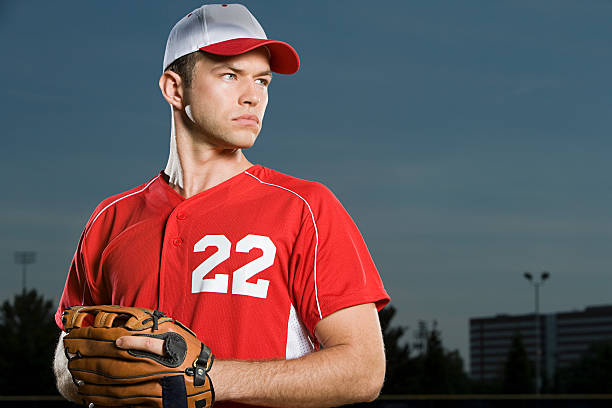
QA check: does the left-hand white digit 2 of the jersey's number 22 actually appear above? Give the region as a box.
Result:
[191,235,232,293]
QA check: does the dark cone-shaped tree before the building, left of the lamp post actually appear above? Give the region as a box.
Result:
[502,332,535,394]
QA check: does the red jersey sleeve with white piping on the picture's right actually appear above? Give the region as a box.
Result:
[290,185,389,334]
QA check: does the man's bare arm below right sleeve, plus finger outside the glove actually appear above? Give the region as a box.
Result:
[110,303,385,408]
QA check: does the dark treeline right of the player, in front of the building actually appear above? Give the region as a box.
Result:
[379,306,612,394]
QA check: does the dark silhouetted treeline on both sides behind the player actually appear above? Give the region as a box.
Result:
[0,290,612,395]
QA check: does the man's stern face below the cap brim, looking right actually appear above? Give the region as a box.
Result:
[185,47,272,149]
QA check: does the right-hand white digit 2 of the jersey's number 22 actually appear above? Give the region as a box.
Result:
[232,235,276,299]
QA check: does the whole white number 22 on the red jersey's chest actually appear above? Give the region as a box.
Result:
[191,234,276,299]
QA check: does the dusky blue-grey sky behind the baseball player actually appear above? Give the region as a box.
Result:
[0,0,612,370]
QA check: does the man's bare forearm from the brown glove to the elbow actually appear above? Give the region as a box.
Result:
[210,345,385,407]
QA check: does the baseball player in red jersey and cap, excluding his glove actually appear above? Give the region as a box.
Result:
[55,4,389,407]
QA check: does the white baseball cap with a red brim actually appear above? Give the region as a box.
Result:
[162,4,300,74]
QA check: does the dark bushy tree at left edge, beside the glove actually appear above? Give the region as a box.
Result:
[0,289,59,395]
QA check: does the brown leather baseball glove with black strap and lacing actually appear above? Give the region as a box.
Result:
[62,305,214,408]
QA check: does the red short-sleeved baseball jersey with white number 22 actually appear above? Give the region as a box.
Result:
[55,165,389,360]
